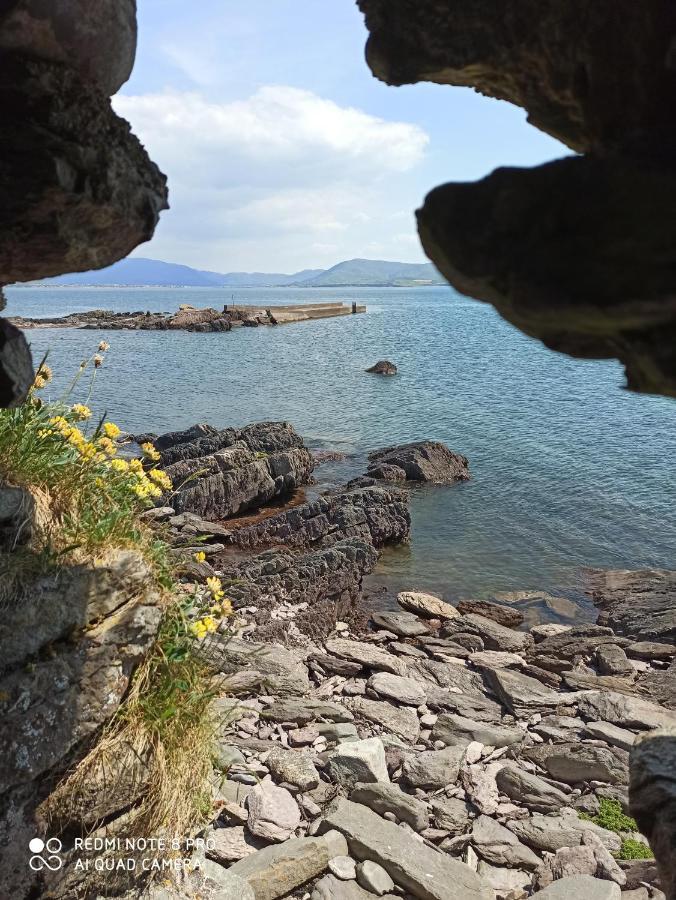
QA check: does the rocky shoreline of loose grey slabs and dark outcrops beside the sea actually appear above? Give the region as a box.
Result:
[38,423,676,900]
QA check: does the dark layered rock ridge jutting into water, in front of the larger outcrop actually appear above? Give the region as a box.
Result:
[232,487,411,550]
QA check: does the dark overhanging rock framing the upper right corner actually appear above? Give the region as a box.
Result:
[359,0,676,396]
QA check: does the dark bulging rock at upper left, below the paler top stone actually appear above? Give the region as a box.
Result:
[0,53,166,284]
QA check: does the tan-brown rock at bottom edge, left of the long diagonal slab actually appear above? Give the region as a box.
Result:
[228,837,347,900]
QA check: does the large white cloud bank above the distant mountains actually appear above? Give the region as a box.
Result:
[114,85,428,270]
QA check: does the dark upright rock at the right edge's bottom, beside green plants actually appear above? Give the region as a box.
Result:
[629,725,676,897]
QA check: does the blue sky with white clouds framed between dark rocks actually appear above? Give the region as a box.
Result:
[119,0,567,272]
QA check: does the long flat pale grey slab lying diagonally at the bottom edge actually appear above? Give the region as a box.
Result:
[320,799,495,900]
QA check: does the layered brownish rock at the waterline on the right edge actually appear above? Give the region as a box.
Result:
[592,570,676,644]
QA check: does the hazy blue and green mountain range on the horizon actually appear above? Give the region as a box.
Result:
[32,257,445,288]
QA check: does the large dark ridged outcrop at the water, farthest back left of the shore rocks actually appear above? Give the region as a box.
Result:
[158,422,315,519]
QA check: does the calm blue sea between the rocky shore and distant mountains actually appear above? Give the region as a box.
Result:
[7,288,676,616]
